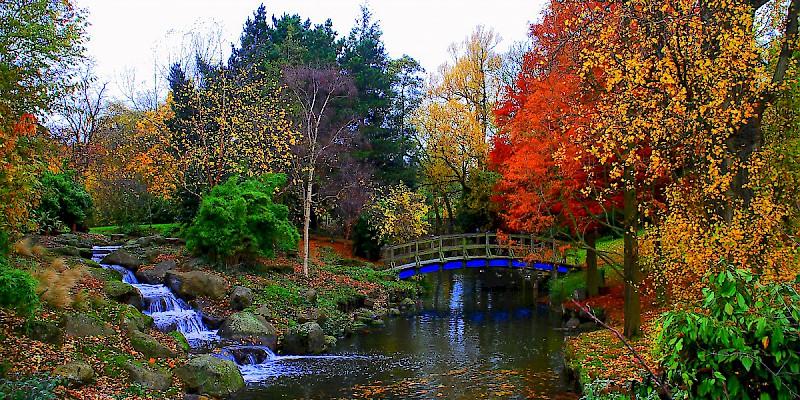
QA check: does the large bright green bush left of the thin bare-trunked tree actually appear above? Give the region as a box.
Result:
[186,174,300,262]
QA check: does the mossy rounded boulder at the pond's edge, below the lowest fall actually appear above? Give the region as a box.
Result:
[175,354,244,397]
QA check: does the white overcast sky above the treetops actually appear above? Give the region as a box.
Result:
[75,0,545,100]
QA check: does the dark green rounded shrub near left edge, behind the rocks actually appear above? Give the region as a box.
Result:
[34,171,92,231]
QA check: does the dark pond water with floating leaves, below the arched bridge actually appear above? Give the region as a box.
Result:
[236,269,578,399]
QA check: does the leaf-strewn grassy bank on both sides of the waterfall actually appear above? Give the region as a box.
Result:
[0,234,420,399]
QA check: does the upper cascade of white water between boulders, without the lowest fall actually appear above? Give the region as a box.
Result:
[92,246,221,348]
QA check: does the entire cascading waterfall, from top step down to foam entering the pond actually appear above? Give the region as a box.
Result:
[92,246,361,382]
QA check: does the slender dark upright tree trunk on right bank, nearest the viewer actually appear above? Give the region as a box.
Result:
[623,166,642,339]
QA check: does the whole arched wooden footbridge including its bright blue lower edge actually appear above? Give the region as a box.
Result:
[381,233,578,279]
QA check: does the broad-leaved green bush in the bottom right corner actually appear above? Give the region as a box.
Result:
[656,267,800,399]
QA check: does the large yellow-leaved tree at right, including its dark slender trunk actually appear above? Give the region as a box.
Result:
[575,0,797,336]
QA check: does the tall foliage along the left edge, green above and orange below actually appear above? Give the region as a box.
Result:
[0,0,86,229]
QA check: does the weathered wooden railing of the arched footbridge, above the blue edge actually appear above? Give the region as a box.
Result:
[381,233,565,269]
